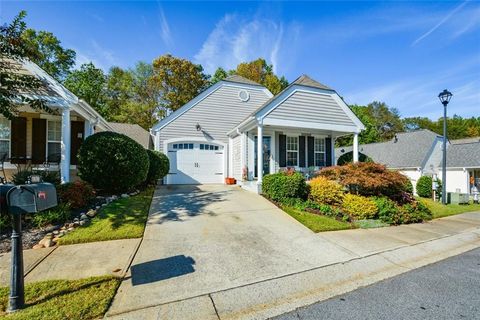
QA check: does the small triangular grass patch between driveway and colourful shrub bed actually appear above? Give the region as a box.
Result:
[282,206,353,232]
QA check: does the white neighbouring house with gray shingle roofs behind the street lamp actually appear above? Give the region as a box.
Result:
[336,130,480,193]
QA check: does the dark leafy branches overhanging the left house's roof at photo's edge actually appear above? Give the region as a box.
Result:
[0,11,51,119]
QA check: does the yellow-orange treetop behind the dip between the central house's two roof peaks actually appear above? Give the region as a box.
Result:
[233,58,288,94]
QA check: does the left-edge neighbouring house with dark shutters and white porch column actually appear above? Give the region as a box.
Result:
[0,61,112,182]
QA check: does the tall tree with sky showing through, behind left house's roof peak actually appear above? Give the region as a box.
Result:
[22,29,76,81]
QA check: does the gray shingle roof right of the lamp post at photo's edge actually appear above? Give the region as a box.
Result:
[447,142,480,168]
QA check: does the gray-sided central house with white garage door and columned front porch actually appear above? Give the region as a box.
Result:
[151,75,364,192]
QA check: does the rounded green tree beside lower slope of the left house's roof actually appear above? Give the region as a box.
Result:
[64,62,108,117]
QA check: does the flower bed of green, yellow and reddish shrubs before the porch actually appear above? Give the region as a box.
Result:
[262,163,432,231]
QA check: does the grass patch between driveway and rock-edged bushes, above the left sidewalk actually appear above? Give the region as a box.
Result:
[59,187,154,245]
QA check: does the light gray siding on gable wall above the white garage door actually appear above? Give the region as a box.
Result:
[159,84,269,151]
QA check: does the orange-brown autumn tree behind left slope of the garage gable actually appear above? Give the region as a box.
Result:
[153,54,208,111]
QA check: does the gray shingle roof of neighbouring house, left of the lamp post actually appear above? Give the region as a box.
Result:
[335,129,441,169]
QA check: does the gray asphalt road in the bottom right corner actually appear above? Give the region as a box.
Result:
[274,249,480,320]
